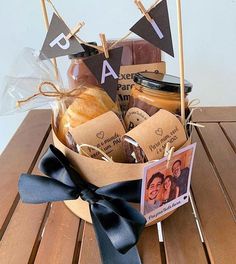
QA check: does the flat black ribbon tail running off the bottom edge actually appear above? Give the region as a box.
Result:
[90,210,142,264]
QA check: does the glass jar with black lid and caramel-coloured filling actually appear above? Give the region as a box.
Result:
[125,72,192,130]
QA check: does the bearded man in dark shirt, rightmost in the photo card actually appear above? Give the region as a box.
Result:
[172,160,189,196]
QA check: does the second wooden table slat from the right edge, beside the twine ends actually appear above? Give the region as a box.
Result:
[199,123,236,214]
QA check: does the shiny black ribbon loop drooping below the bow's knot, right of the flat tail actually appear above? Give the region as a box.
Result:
[90,199,146,254]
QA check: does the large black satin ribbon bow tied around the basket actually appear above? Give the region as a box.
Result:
[18,145,146,264]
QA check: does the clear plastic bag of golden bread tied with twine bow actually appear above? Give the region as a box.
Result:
[0,48,119,149]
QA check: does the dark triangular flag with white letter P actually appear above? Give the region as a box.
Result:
[39,13,84,60]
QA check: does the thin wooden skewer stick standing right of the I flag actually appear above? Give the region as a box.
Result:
[176,0,185,127]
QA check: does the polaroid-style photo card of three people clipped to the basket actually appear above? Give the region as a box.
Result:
[140,143,196,223]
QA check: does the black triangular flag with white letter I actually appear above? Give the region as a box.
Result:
[130,0,174,57]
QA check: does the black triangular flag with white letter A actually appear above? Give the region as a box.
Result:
[84,47,123,101]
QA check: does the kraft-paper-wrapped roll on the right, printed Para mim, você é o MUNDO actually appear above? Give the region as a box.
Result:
[123,109,187,161]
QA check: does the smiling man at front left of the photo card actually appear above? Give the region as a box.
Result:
[144,172,164,214]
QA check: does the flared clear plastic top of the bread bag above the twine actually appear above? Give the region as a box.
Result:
[0,48,63,115]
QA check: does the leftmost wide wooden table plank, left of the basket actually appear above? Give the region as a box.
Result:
[0,110,50,239]
